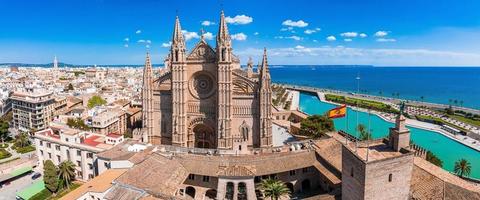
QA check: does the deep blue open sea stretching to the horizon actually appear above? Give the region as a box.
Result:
[270,65,480,109]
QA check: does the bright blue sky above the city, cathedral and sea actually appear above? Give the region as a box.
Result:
[0,0,480,66]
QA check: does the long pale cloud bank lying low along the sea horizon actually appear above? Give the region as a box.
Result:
[236,46,480,66]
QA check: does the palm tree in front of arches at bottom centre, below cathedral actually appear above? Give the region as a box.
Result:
[258,178,290,200]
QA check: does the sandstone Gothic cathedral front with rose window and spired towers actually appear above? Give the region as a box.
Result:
[142,12,272,151]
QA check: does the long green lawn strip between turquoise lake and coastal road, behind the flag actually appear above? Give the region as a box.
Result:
[325,94,398,114]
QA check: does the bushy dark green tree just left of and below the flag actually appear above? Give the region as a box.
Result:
[299,115,335,138]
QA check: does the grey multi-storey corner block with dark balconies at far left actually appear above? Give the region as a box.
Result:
[10,89,55,132]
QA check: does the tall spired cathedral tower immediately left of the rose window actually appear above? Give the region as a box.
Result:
[169,16,188,146]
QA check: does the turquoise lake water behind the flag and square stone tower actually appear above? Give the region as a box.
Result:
[300,92,480,179]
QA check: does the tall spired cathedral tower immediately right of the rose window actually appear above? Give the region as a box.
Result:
[216,11,233,149]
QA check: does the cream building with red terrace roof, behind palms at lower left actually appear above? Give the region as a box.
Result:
[34,123,124,181]
